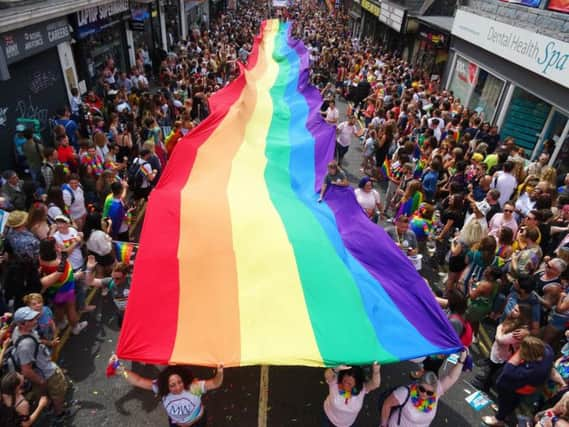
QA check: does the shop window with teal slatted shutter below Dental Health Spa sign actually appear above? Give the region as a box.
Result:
[500,87,551,155]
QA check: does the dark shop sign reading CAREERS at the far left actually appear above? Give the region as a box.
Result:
[0,18,71,64]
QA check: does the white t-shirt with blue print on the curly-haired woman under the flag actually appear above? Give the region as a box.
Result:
[152,381,206,424]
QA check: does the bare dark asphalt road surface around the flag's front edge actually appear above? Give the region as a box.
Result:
[39,102,492,427]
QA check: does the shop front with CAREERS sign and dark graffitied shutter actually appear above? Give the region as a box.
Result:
[0,18,75,170]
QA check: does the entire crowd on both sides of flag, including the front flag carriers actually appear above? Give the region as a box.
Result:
[0,2,569,427]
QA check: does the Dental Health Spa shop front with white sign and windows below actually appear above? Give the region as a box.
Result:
[447,9,569,169]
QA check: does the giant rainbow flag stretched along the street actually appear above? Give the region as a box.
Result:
[118,20,461,366]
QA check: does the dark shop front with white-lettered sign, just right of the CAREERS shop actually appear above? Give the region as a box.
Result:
[73,0,131,92]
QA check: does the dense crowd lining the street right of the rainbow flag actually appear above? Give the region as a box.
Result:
[306,4,569,426]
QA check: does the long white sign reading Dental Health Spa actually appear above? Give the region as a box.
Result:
[452,10,569,88]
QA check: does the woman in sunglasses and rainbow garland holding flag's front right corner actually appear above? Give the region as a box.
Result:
[380,349,468,427]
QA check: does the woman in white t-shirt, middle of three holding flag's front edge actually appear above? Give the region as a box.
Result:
[322,362,381,427]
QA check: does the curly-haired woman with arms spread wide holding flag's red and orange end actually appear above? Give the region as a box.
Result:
[109,356,223,427]
